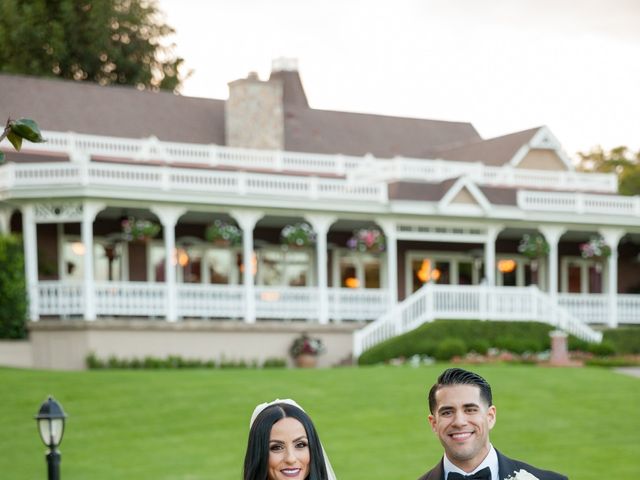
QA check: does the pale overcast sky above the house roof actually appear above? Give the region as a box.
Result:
[158,0,640,156]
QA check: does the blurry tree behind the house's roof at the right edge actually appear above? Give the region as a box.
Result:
[578,146,640,195]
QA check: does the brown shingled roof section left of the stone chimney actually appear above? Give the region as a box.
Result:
[0,75,225,144]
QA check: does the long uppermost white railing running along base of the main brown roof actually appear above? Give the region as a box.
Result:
[3,131,617,193]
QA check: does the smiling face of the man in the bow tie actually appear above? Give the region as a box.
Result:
[429,385,496,472]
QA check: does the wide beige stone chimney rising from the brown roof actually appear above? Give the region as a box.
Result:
[225,72,284,150]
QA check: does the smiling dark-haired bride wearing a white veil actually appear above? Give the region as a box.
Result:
[243,399,336,480]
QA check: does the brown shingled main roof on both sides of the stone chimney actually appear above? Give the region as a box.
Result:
[0,71,538,165]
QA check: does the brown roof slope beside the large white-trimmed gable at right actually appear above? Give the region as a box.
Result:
[437,127,544,166]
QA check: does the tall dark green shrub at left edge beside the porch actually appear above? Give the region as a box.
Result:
[0,235,27,339]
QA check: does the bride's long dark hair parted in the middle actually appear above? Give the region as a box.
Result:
[242,403,328,480]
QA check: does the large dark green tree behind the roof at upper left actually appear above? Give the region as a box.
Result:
[0,0,183,91]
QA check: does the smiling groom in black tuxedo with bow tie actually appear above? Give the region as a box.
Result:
[418,368,567,480]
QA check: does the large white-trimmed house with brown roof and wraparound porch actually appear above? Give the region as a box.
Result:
[0,59,640,368]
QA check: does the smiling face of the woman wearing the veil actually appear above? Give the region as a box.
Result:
[268,417,311,480]
